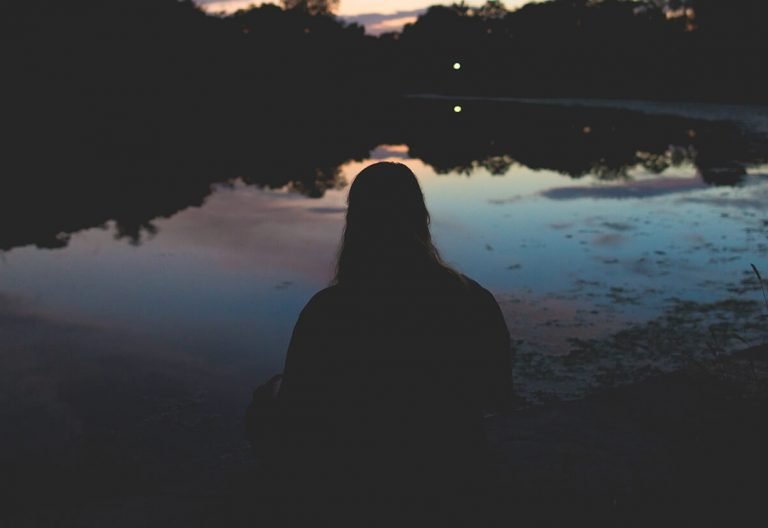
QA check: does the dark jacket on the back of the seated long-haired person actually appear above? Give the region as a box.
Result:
[279,267,511,500]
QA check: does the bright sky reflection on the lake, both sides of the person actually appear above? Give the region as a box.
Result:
[0,145,768,380]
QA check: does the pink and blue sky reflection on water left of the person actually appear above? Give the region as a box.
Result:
[0,186,341,374]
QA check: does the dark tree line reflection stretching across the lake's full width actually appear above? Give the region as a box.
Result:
[0,100,768,256]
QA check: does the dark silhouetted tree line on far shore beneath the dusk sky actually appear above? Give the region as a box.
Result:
[0,0,768,179]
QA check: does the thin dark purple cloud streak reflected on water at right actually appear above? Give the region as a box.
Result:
[541,177,707,200]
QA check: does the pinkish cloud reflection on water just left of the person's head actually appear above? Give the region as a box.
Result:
[150,185,346,283]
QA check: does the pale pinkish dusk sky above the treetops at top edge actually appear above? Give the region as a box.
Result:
[195,0,542,34]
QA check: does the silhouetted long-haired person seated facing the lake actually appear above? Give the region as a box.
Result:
[270,162,511,526]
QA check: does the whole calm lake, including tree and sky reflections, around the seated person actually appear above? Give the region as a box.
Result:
[0,99,768,504]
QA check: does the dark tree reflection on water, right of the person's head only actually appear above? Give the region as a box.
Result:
[404,101,768,185]
